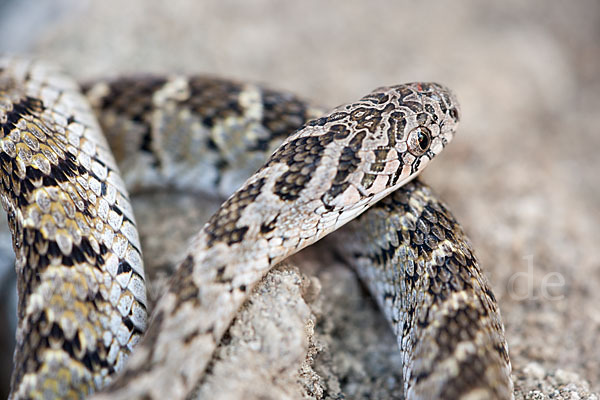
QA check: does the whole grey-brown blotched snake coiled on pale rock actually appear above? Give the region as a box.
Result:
[0,57,513,399]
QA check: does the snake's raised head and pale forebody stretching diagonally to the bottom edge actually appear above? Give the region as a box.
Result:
[92,83,458,399]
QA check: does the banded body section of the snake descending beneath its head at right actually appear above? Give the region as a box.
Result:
[332,179,512,399]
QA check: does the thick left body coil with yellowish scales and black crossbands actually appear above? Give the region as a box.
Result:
[0,59,147,399]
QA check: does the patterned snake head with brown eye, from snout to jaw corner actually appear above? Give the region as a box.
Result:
[309,83,460,216]
